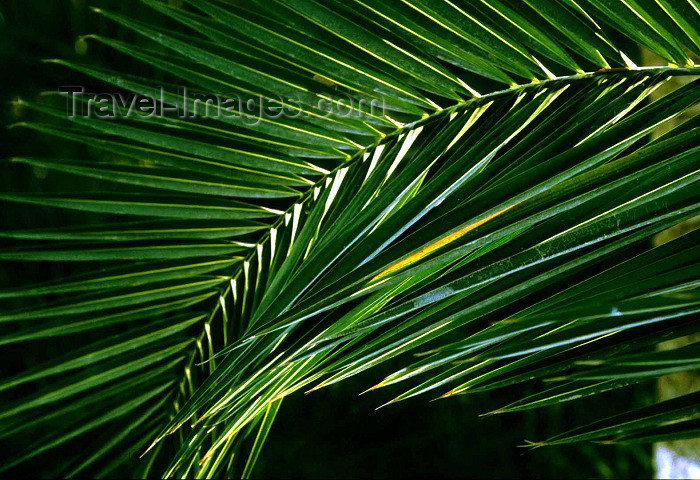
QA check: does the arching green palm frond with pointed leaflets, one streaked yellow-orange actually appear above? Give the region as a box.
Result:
[0,0,700,478]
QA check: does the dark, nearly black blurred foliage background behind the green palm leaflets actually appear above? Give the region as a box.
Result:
[0,0,654,478]
